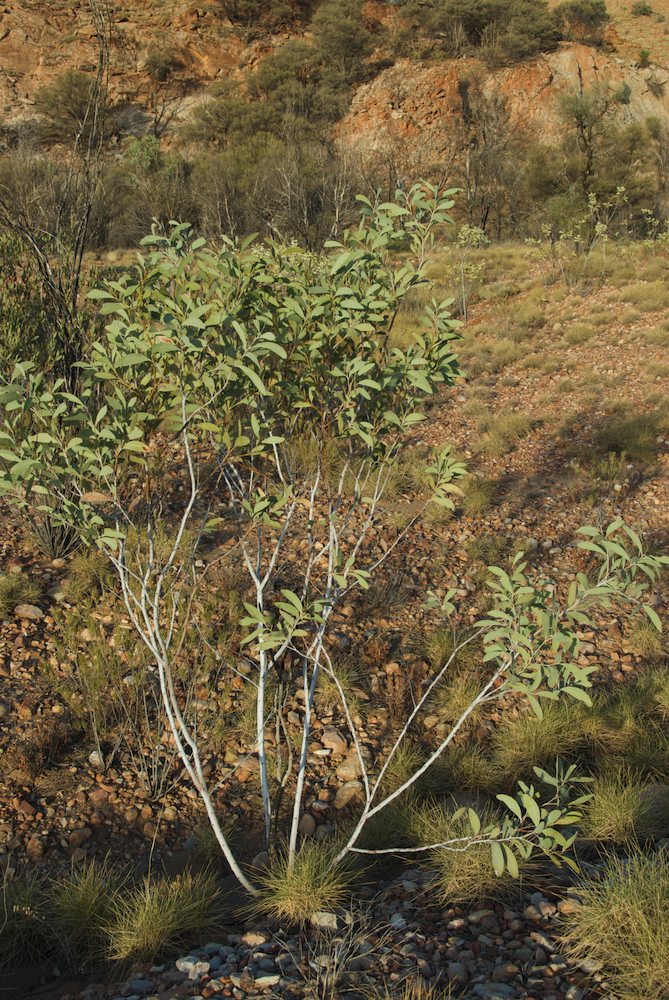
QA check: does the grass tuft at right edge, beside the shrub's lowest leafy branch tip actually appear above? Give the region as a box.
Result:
[581,767,669,845]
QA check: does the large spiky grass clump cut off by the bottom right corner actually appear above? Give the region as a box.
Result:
[563,853,669,1000]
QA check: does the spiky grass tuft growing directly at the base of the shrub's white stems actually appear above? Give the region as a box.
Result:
[253,841,355,924]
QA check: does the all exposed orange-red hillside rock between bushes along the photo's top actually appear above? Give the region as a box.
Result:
[0,0,669,156]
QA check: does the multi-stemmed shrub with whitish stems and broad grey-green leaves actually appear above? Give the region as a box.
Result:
[0,186,669,897]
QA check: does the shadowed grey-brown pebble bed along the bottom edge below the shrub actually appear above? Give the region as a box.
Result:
[85,870,594,1000]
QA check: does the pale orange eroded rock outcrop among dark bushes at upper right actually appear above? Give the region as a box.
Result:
[338,44,669,161]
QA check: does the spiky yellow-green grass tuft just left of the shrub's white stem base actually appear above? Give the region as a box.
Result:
[107,872,223,962]
